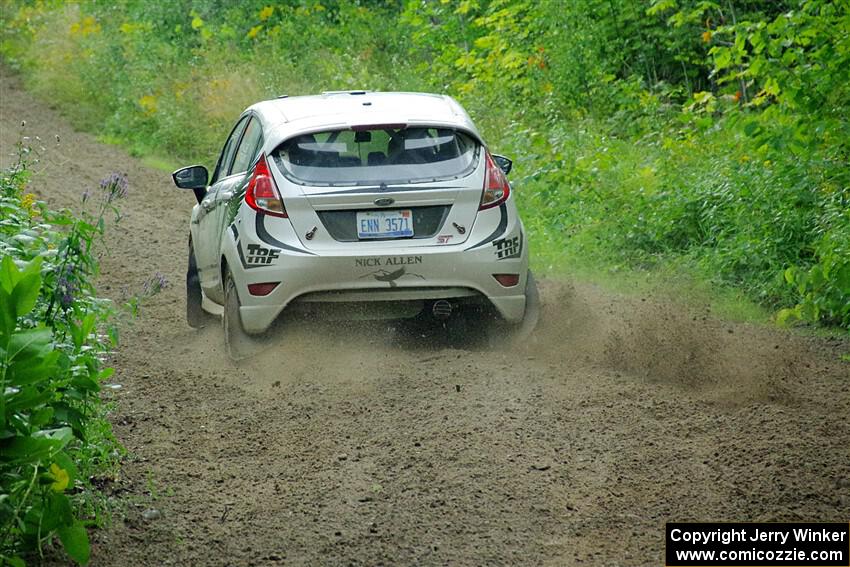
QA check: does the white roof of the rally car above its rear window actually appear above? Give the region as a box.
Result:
[246,91,484,150]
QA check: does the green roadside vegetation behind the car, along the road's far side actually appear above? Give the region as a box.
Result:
[0,0,850,329]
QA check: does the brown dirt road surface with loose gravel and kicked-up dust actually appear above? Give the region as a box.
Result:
[0,71,850,567]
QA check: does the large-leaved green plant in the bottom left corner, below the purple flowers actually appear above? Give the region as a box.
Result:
[0,256,96,564]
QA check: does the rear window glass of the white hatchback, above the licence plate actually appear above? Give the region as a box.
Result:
[273,126,479,186]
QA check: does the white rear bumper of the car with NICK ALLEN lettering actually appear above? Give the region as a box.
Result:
[223,209,528,334]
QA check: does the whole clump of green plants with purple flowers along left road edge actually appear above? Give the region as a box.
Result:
[0,149,132,564]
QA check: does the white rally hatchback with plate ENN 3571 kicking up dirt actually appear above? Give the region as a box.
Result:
[172,91,538,358]
